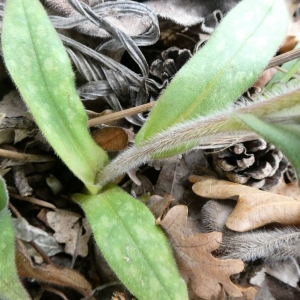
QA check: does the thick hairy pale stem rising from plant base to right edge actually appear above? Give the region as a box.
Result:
[98,78,300,185]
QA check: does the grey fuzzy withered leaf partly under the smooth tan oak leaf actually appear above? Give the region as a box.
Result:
[201,200,300,261]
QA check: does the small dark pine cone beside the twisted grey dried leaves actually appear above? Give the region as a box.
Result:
[150,47,192,81]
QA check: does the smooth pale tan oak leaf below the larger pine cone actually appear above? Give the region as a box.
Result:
[189,175,300,232]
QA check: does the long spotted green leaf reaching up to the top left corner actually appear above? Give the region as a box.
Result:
[2,0,108,192]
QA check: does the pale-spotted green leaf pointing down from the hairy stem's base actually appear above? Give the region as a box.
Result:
[73,185,188,300]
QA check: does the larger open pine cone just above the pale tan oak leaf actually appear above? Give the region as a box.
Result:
[207,139,296,190]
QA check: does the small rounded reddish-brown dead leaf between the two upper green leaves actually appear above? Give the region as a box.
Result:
[93,127,128,151]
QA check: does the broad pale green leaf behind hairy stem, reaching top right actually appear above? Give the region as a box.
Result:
[136,0,288,158]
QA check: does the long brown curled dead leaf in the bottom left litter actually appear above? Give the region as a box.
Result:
[16,250,92,297]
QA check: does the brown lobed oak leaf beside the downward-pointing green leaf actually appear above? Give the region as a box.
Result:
[157,205,256,299]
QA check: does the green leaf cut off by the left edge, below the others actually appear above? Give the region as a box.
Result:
[0,177,30,300]
